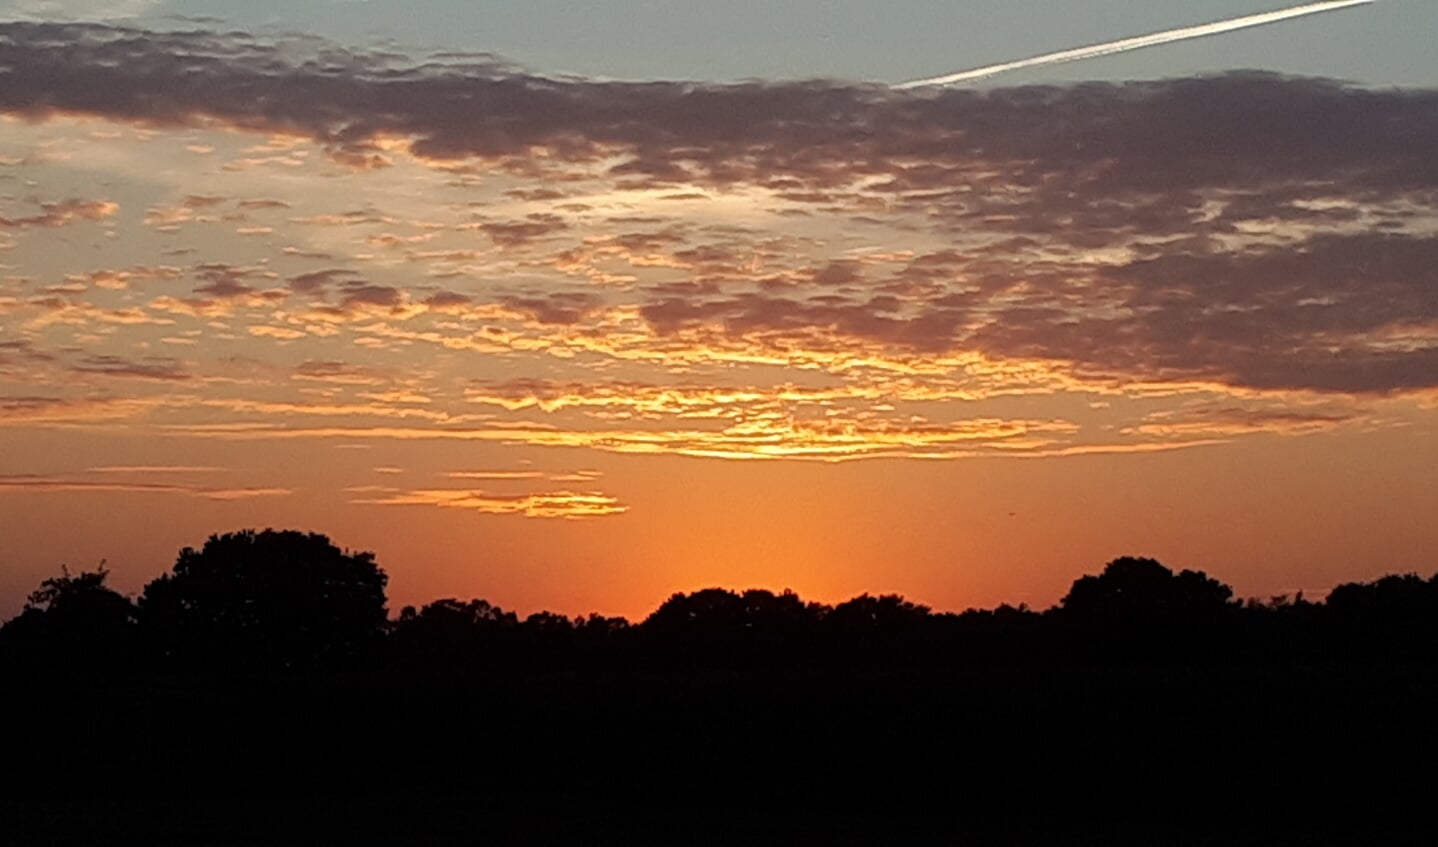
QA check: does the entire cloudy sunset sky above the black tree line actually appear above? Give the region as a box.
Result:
[0,0,1438,617]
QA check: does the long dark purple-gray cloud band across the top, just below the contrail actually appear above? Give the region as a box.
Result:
[0,23,1438,204]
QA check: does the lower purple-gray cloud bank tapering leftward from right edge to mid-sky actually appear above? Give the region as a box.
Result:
[640,227,1438,394]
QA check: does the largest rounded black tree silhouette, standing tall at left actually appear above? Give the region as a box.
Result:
[139,529,387,667]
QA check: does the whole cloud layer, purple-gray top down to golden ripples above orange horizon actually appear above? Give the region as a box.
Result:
[0,23,1438,518]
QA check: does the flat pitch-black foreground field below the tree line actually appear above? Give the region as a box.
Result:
[3,660,1438,844]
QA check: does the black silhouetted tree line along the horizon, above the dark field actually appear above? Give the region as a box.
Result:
[0,520,1438,674]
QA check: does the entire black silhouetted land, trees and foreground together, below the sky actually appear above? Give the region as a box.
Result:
[0,531,1438,844]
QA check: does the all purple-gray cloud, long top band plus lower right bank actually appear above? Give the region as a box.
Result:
[0,23,1438,394]
